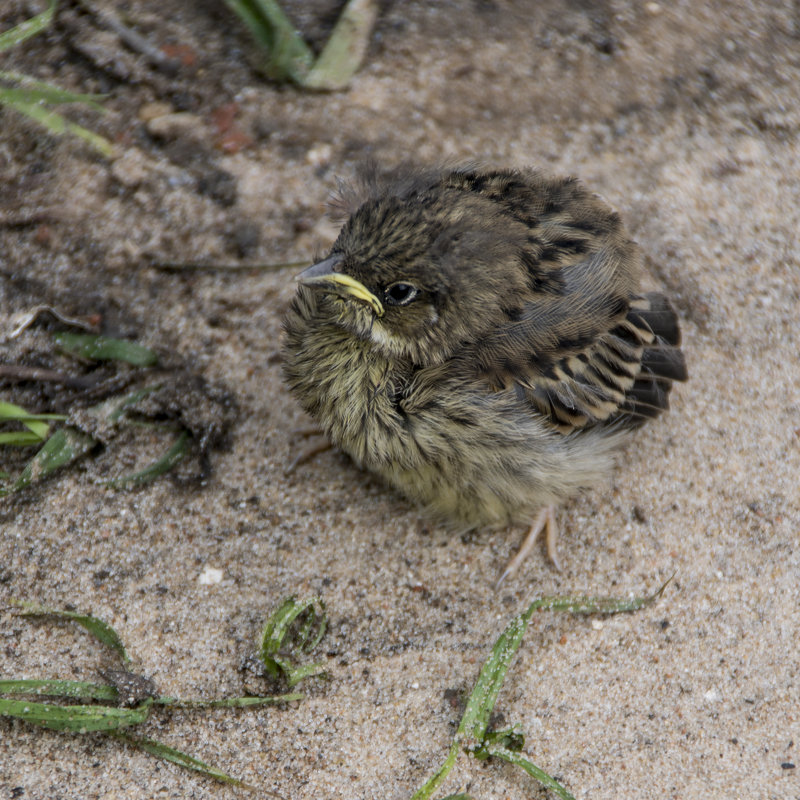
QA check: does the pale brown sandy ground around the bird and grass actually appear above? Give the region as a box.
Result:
[0,0,800,800]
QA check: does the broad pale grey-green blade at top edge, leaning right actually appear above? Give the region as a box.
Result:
[302,0,378,90]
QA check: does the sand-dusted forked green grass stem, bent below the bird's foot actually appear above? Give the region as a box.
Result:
[412,577,672,800]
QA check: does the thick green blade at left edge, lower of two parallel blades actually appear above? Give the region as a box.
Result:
[0,698,152,733]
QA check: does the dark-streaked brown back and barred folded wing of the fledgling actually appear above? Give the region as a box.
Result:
[438,170,687,432]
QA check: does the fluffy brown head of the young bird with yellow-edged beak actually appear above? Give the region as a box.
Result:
[298,193,526,366]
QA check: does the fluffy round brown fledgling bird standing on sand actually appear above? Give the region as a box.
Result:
[283,164,688,580]
